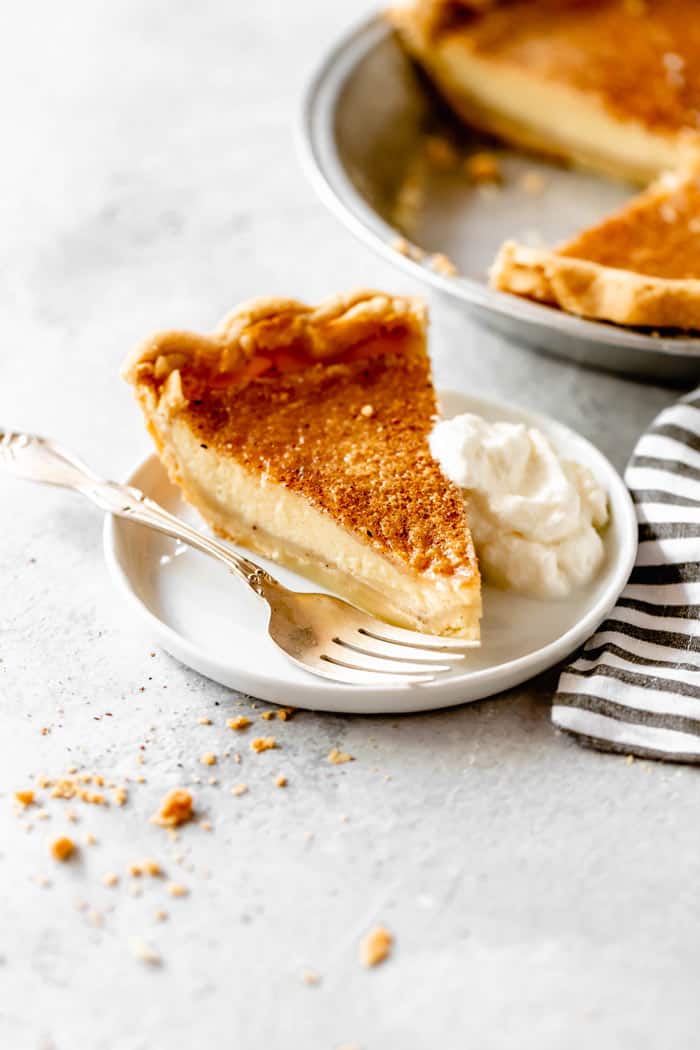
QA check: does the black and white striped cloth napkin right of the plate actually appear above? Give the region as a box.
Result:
[552,387,700,762]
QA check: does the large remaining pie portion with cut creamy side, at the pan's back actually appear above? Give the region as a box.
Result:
[389,0,700,183]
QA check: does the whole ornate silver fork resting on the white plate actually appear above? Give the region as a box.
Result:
[0,429,478,686]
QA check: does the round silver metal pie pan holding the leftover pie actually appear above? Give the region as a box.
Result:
[299,16,700,384]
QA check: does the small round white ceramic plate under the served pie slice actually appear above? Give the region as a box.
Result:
[104,393,637,714]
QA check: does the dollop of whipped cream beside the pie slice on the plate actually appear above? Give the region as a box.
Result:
[430,413,608,597]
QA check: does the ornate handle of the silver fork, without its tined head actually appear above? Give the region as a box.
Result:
[0,429,279,595]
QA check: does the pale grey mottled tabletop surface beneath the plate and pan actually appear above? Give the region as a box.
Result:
[0,0,700,1050]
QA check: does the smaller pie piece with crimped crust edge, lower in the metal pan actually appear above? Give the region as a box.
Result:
[491,153,700,329]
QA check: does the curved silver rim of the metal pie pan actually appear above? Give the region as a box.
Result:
[296,15,700,360]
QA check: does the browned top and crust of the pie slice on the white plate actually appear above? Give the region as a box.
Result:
[126,293,478,579]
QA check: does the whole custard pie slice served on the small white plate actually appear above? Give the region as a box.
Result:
[124,292,481,638]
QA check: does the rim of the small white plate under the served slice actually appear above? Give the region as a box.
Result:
[103,390,637,714]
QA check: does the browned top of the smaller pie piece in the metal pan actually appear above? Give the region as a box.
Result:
[557,159,700,279]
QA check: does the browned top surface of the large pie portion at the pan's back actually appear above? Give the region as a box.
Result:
[432,0,700,132]
